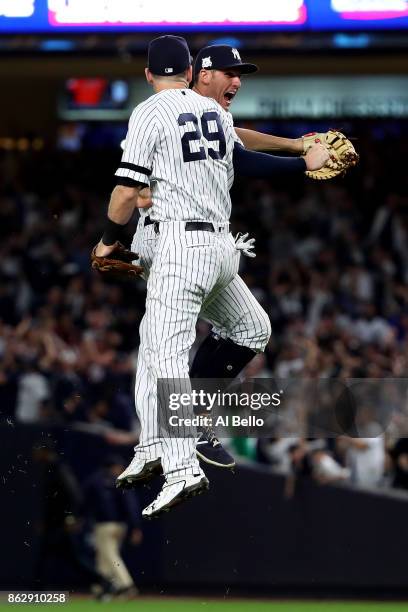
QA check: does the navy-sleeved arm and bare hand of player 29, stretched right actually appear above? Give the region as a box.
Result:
[233,143,330,178]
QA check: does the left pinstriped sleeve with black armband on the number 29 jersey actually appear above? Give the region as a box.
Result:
[115,103,158,187]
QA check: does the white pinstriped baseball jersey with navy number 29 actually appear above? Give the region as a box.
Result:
[116,89,240,223]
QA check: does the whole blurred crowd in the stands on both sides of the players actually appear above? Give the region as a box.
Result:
[0,126,408,488]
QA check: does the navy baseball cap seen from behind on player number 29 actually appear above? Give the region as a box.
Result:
[147,35,192,76]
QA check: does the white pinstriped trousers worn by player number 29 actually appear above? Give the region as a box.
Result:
[145,222,238,475]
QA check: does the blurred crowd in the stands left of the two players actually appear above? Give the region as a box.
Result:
[0,153,145,440]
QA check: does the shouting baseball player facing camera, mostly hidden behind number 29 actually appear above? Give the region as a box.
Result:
[118,45,328,487]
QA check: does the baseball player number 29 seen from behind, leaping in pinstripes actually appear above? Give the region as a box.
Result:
[95,36,328,517]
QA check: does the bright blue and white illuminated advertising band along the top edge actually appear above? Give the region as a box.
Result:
[0,0,408,34]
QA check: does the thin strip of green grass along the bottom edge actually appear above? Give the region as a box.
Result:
[0,597,408,612]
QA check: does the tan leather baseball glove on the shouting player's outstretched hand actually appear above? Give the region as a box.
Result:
[303,130,359,181]
